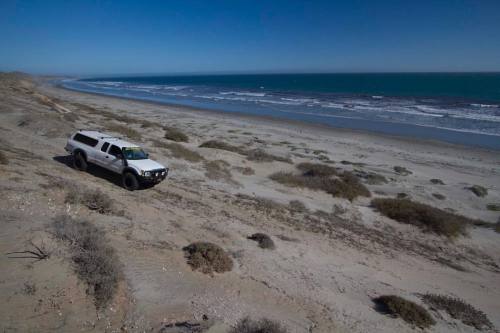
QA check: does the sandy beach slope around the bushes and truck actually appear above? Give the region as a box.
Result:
[0,74,500,332]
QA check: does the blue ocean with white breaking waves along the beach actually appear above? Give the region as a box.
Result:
[61,73,500,150]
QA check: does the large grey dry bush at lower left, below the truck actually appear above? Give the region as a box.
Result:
[53,216,122,308]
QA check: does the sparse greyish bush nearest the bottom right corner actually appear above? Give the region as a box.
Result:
[422,294,493,330]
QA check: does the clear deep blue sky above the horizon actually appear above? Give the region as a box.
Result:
[0,0,500,75]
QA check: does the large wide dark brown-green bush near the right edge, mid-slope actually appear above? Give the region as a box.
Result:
[371,198,481,237]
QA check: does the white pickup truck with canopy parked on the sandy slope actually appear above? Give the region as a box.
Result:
[64,130,168,191]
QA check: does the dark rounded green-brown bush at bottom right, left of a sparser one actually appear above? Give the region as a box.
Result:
[373,295,436,328]
